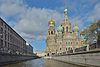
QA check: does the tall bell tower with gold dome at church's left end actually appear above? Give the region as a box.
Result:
[46,18,56,56]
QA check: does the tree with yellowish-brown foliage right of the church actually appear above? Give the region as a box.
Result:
[80,20,100,47]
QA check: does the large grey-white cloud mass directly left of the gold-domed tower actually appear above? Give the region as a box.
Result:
[14,7,62,42]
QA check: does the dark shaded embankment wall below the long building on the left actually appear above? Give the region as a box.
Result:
[0,53,38,65]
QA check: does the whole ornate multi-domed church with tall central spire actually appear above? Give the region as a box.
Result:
[46,9,83,55]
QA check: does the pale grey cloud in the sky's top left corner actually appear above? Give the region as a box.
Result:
[0,0,26,16]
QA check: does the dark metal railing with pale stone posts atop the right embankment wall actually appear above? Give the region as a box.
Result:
[52,43,100,56]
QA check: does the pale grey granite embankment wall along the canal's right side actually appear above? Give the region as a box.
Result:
[52,50,100,67]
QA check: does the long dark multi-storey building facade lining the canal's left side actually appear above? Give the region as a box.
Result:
[0,18,33,53]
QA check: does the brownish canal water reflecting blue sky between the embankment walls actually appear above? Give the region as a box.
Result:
[3,58,83,67]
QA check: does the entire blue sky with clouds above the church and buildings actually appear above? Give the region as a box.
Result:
[0,0,100,52]
